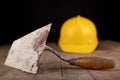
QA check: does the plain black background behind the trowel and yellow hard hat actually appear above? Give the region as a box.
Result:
[0,0,120,45]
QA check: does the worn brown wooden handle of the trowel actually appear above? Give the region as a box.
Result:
[69,57,114,70]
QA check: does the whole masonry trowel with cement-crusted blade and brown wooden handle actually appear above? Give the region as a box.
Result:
[4,23,114,74]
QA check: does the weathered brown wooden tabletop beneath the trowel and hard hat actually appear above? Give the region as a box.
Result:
[0,40,120,80]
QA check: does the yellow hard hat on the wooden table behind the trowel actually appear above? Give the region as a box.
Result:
[58,15,98,54]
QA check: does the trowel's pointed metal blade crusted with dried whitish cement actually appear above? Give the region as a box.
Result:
[5,24,51,74]
